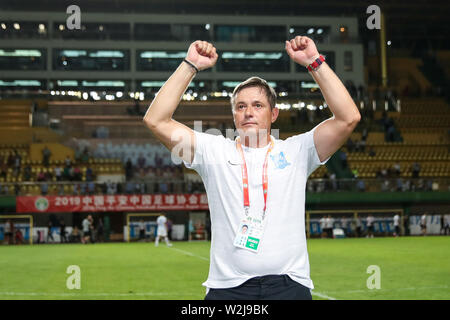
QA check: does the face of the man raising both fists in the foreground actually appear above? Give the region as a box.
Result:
[233,87,278,135]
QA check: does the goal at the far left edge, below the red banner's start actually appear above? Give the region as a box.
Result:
[0,214,33,245]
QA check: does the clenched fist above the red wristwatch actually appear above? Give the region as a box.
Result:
[286,36,320,67]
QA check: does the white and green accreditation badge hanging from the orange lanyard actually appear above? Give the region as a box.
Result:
[234,216,264,253]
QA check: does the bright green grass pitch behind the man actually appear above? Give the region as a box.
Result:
[0,236,450,300]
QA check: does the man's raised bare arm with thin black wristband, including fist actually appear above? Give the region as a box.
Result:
[144,41,218,163]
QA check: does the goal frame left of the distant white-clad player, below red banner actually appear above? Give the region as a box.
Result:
[123,213,161,242]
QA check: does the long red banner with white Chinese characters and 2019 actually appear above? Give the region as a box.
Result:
[16,194,208,213]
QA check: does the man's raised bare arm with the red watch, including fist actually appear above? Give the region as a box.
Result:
[286,36,361,162]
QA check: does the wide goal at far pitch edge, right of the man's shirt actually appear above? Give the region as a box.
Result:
[306,209,404,238]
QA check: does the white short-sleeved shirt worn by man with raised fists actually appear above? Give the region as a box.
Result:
[184,128,328,289]
